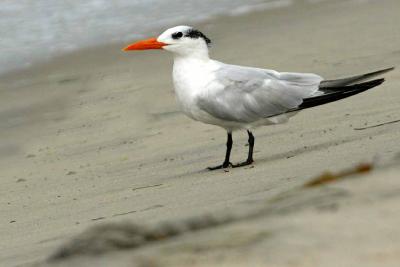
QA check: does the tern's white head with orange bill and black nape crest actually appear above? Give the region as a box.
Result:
[123,26,211,57]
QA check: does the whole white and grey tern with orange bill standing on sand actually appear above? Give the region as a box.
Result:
[123,26,394,170]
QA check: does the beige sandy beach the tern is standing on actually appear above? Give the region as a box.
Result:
[0,0,400,266]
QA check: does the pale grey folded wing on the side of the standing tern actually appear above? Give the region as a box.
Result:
[197,63,322,123]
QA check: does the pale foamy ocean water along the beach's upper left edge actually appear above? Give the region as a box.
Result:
[0,0,293,74]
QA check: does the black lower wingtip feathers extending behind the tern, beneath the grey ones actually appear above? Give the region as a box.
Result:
[296,78,385,110]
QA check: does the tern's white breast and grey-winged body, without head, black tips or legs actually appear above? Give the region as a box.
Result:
[173,56,322,131]
